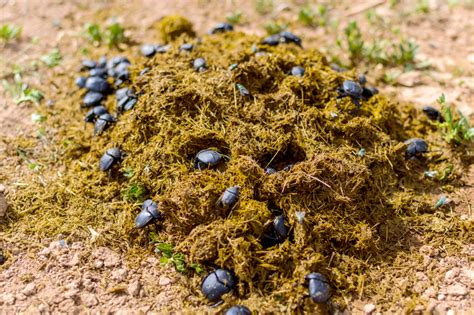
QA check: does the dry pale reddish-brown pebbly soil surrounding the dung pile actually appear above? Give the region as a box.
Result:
[0,0,474,314]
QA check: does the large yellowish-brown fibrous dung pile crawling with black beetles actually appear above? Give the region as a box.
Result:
[2,19,472,313]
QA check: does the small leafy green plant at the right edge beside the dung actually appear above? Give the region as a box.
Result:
[437,94,474,144]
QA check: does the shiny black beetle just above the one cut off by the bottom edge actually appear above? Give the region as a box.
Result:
[201,269,236,302]
